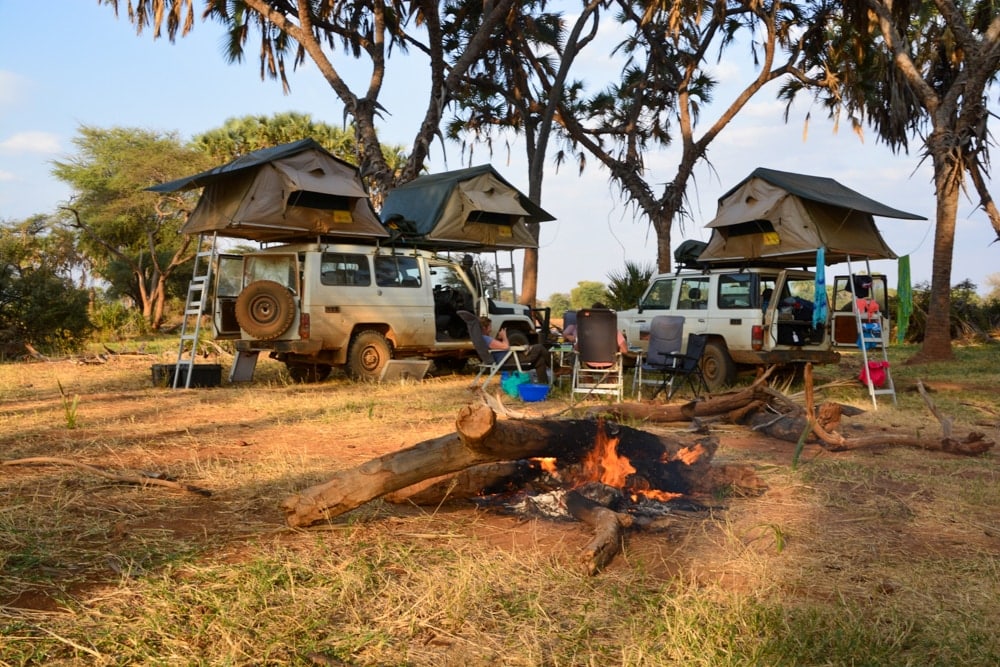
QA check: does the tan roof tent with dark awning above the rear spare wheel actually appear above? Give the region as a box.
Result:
[148,139,389,242]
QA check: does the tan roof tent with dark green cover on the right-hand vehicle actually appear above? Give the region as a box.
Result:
[698,167,926,267]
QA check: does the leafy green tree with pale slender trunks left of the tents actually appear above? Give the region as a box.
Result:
[52,125,208,329]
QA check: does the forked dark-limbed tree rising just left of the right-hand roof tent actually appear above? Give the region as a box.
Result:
[559,0,821,272]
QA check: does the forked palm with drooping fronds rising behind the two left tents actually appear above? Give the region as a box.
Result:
[101,0,515,196]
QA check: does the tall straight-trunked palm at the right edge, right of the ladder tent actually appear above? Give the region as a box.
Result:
[784,0,1000,362]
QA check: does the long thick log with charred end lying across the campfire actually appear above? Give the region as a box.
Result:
[281,405,718,526]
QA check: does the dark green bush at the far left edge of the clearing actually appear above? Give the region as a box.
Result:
[0,217,91,354]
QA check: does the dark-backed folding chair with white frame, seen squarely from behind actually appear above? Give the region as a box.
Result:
[572,309,624,402]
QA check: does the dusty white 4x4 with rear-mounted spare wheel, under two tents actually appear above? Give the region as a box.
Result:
[212,243,548,381]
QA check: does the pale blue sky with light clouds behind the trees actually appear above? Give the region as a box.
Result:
[0,0,1000,298]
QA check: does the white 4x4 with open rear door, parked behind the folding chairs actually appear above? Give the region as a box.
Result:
[618,268,840,390]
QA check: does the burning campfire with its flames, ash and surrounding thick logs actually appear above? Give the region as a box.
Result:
[283,406,752,573]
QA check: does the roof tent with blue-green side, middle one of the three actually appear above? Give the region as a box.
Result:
[380,164,555,251]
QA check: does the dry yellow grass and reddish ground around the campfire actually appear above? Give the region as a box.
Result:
[0,347,1000,666]
